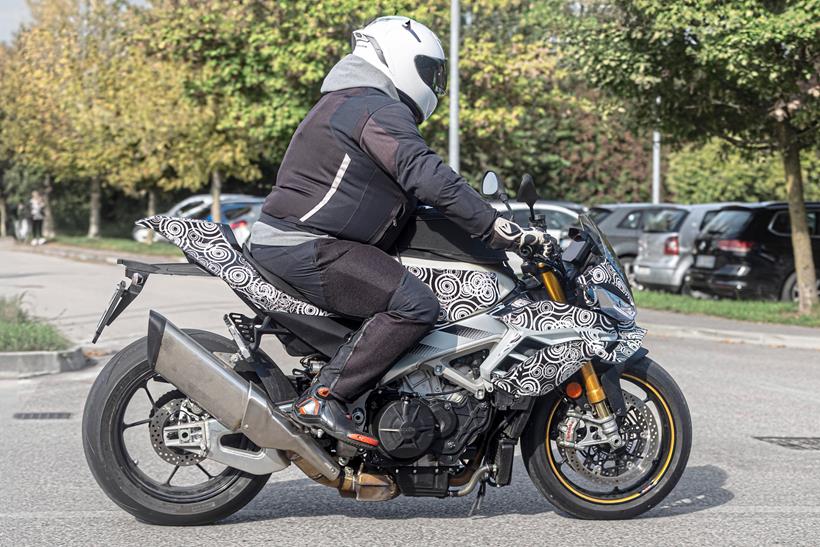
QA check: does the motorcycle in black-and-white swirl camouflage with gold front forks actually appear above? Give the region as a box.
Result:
[83,172,692,525]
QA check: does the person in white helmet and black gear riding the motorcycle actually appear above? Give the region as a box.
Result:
[249,17,554,448]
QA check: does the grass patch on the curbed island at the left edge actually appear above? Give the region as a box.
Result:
[0,295,70,351]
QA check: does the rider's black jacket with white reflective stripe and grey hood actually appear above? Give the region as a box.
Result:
[261,56,496,250]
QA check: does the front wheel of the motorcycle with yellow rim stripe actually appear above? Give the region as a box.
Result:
[521,358,692,519]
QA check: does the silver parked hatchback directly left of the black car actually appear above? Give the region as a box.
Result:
[634,203,729,292]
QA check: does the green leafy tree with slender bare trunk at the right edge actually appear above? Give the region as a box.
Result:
[549,0,820,313]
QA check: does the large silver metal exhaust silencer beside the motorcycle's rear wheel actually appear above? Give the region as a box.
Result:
[148,310,341,480]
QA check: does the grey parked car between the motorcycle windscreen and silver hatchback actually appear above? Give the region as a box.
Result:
[589,203,679,284]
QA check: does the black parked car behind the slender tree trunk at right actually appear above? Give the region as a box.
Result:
[688,202,820,300]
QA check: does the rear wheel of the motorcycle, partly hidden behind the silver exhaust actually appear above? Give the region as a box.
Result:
[83,331,270,526]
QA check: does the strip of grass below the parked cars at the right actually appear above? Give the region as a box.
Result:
[635,291,820,327]
